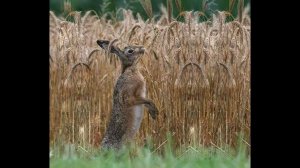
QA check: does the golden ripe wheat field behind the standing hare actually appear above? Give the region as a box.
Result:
[49,7,250,155]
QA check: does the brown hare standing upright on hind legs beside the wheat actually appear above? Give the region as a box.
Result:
[97,40,158,149]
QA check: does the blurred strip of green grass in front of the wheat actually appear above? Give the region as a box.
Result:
[50,144,250,168]
